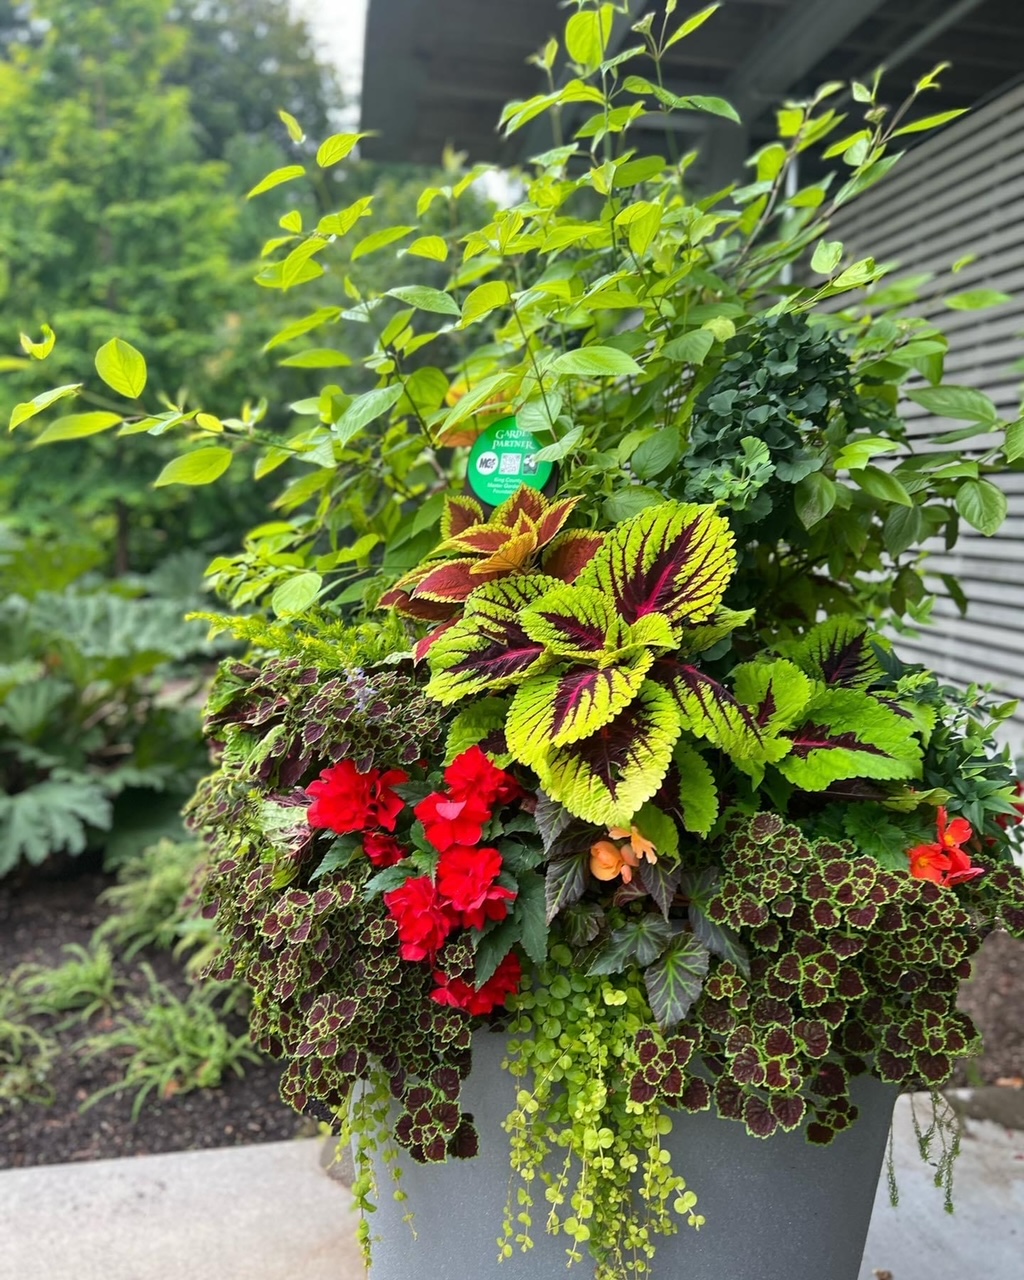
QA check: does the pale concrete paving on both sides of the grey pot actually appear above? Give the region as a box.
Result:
[0,1089,1024,1280]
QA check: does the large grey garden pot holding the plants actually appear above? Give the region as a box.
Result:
[370,1032,897,1280]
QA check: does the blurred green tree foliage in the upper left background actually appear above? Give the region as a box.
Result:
[0,0,337,571]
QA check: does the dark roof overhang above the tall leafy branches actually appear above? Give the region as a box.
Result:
[362,0,1024,184]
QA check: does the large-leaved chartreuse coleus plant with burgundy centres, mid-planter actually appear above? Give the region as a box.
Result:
[428,502,920,832]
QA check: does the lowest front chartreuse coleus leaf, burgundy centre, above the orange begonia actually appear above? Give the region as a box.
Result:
[532,680,680,827]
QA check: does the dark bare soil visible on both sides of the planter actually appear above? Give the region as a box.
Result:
[0,874,1024,1169]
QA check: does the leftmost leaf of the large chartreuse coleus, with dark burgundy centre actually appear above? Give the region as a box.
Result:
[426,573,556,704]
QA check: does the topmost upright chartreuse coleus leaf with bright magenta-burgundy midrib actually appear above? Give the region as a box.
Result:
[576,502,736,626]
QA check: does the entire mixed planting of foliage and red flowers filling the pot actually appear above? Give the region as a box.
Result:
[19,0,1024,1280]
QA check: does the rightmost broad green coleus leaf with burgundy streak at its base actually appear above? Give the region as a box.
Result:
[778,689,920,791]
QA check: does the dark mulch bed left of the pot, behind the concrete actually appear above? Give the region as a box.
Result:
[0,874,305,1169]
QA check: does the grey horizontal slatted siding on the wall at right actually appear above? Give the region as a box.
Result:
[833,86,1024,748]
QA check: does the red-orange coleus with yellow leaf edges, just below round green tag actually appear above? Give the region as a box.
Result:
[380,485,604,658]
